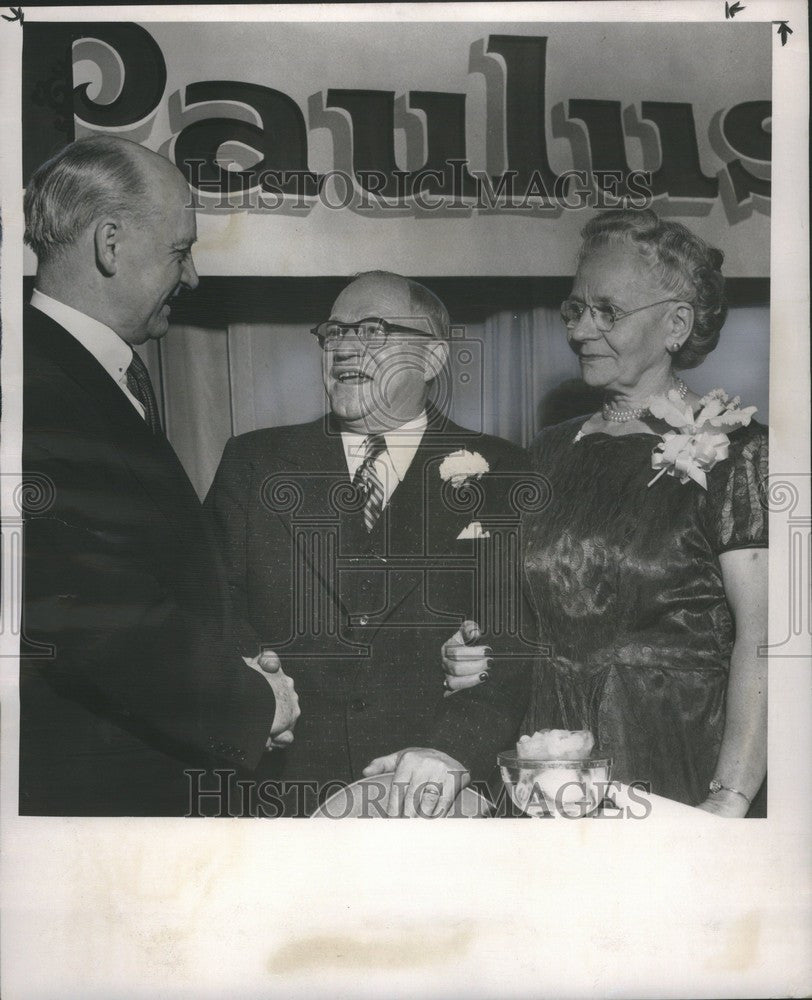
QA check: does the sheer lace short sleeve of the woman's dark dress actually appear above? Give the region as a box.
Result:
[707,422,769,553]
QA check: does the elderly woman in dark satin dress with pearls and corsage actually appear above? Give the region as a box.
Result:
[444,211,767,816]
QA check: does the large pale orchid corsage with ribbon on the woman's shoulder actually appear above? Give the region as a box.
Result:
[648,389,757,490]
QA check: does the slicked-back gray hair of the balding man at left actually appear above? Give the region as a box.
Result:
[23,135,151,264]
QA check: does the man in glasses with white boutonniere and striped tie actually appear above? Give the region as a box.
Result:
[205,272,529,815]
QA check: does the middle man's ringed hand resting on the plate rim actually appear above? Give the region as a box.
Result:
[364,747,471,818]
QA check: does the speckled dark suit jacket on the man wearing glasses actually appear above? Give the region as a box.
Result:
[205,411,531,804]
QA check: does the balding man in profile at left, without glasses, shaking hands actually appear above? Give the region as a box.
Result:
[20,136,298,816]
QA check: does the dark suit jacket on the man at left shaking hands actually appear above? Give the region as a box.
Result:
[20,306,275,815]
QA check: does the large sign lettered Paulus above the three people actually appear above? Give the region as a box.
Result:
[26,23,771,274]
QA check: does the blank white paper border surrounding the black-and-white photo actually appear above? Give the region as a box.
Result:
[0,0,812,1000]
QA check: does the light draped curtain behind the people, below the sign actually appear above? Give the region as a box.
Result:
[142,307,769,497]
